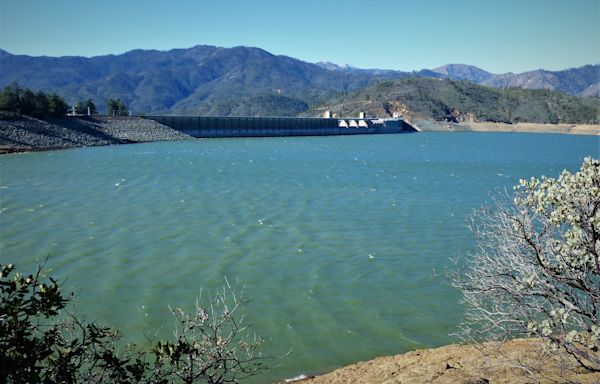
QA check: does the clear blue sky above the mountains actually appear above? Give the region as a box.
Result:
[0,0,600,73]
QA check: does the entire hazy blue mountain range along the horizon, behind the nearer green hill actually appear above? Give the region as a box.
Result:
[0,45,600,116]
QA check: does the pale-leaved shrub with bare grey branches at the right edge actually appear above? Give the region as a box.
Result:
[454,158,600,371]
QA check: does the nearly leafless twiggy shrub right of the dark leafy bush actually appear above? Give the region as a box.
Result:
[154,280,267,384]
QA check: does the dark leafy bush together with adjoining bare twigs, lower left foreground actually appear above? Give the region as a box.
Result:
[0,265,266,383]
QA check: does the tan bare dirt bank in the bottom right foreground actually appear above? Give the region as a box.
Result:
[288,339,600,384]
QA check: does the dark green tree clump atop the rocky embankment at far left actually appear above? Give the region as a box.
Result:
[0,83,68,118]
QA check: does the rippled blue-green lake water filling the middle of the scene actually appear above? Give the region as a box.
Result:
[0,133,600,382]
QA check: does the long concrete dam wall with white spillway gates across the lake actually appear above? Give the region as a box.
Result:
[145,116,416,137]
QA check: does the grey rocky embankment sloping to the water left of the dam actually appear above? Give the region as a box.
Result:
[0,116,192,153]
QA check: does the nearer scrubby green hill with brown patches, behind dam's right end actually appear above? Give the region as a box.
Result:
[306,78,600,124]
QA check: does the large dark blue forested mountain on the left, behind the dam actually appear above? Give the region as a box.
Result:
[0,46,379,115]
